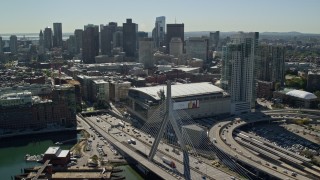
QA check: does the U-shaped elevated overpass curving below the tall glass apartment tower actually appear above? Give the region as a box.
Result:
[209,109,320,179]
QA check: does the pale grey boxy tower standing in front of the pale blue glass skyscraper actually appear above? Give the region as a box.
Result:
[139,38,154,69]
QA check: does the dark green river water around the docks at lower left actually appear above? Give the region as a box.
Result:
[0,132,143,180]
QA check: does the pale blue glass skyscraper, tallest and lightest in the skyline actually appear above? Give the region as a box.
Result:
[152,16,166,48]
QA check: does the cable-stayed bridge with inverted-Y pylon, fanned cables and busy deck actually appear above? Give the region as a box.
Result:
[81,82,245,180]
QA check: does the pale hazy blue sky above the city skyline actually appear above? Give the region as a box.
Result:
[0,0,320,34]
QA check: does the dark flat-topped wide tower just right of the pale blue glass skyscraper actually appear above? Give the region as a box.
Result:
[166,24,184,52]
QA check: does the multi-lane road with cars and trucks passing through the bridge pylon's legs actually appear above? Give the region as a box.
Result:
[81,115,232,179]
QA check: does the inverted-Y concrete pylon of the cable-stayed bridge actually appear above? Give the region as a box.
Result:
[148,80,191,180]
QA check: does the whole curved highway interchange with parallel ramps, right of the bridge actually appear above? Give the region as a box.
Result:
[209,110,320,179]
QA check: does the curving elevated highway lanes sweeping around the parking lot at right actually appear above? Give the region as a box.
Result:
[209,109,320,179]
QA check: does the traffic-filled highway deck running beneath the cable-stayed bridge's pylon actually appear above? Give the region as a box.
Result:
[79,115,232,180]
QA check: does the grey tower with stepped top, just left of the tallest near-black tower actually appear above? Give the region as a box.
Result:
[100,22,117,55]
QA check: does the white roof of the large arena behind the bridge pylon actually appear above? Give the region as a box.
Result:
[130,82,224,100]
